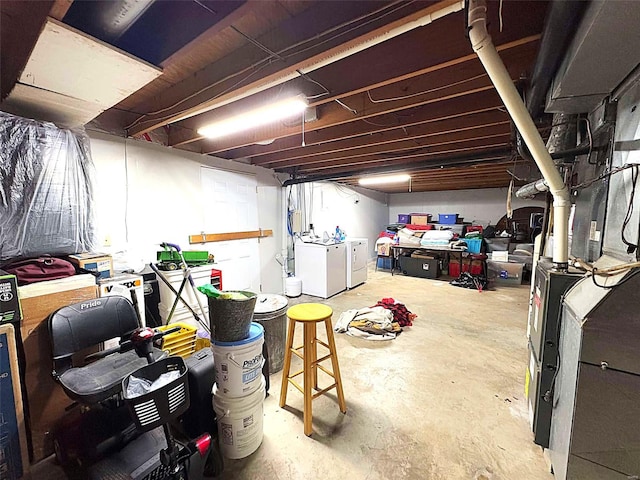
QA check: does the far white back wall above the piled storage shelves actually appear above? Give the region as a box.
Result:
[388,188,544,225]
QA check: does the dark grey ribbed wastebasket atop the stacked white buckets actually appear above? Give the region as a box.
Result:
[209,291,257,342]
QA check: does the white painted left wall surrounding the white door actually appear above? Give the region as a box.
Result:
[89,132,283,293]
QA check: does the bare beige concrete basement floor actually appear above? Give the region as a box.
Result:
[33,270,553,480]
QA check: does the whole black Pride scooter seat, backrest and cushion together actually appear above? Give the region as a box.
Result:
[49,296,164,405]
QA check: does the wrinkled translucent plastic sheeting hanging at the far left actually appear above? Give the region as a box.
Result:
[0,112,95,263]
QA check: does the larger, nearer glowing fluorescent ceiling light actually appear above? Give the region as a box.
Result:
[198,96,307,138]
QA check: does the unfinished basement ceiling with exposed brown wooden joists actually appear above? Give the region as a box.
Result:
[0,0,548,192]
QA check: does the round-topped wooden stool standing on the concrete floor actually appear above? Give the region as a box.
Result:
[280,303,347,436]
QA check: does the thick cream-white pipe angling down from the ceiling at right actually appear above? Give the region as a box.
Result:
[469,0,571,268]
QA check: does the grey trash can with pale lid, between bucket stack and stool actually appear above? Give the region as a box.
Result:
[253,294,289,375]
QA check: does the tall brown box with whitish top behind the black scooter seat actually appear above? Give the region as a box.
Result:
[19,275,98,464]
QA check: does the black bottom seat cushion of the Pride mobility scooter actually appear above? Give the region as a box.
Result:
[58,349,166,404]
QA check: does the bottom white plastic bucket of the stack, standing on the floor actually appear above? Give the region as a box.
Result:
[213,375,266,459]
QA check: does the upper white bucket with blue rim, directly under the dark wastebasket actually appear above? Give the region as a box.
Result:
[211,322,264,397]
